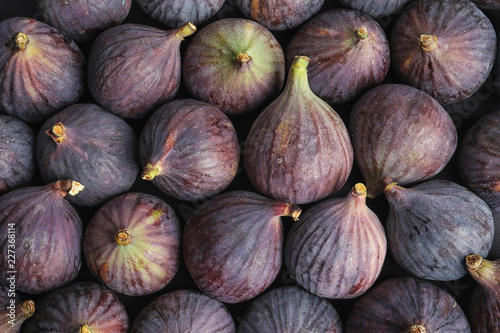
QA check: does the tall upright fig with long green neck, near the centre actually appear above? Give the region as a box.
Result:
[243,56,353,204]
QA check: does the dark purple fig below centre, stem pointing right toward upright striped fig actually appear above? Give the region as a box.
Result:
[182,190,301,303]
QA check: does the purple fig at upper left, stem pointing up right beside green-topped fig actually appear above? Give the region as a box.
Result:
[87,23,196,118]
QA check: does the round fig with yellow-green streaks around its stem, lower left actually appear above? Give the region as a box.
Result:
[83,192,181,296]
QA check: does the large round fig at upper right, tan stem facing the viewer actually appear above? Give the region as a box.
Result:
[389,0,497,104]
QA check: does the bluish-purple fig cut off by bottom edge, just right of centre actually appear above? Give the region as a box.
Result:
[238,286,343,333]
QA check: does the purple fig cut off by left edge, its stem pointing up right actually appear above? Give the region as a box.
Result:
[0,179,83,294]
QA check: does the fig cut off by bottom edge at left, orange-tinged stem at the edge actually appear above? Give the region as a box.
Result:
[23,282,129,333]
